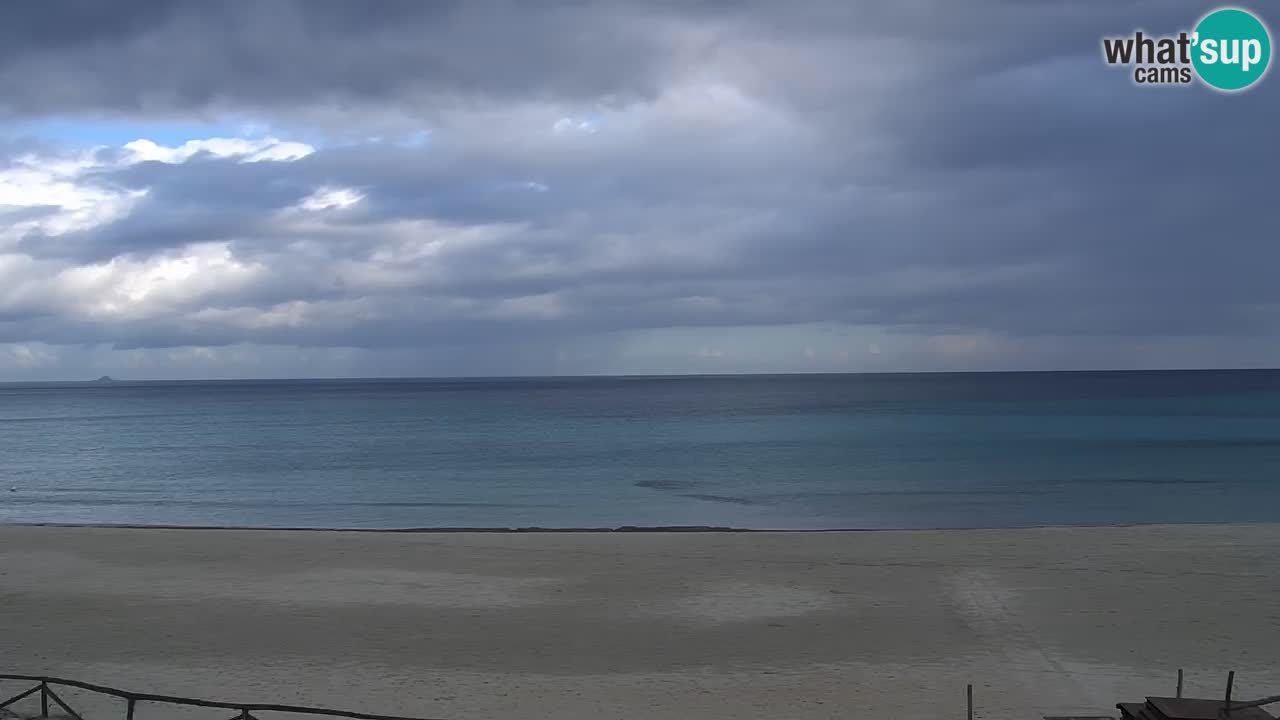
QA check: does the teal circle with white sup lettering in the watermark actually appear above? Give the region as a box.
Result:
[1192,8,1271,92]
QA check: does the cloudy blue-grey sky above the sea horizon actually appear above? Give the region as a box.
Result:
[0,0,1280,380]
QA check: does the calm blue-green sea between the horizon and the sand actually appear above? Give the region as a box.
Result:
[0,370,1280,529]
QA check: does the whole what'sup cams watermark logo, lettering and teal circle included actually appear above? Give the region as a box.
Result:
[1102,8,1271,92]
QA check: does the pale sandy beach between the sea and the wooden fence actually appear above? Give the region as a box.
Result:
[0,525,1280,720]
